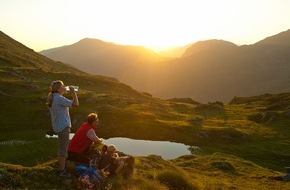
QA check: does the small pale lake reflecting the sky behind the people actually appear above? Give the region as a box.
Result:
[46,133,201,160]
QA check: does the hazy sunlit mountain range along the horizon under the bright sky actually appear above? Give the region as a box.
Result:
[40,30,290,102]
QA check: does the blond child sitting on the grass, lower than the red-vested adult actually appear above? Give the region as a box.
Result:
[99,144,134,177]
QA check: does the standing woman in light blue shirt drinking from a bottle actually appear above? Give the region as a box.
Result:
[46,80,79,177]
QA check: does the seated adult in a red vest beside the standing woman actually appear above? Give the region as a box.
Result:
[68,113,102,165]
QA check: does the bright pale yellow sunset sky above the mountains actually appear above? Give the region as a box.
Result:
[0,0,290,51]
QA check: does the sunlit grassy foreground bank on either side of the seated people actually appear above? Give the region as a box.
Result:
[0,153,290,190]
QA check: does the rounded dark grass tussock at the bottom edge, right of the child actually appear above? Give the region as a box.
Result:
[157,170,197,190]
